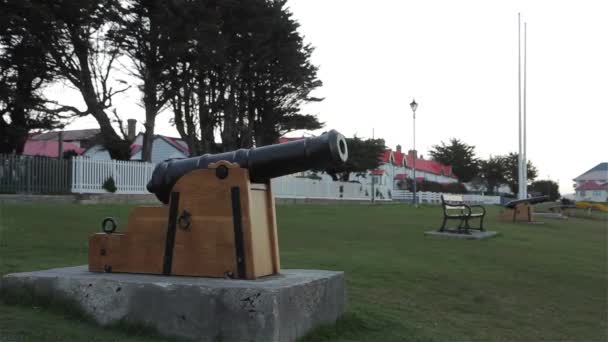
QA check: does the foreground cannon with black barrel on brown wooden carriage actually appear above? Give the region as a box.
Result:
[88,130,348,279]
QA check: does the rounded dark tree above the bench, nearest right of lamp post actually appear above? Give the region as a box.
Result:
[429,138,479,182]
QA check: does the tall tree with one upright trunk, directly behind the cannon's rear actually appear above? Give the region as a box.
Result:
[109,0,186,161]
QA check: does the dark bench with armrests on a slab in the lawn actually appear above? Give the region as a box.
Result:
[439,194,486,234]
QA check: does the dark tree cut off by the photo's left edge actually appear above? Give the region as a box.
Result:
[0,1,62,154]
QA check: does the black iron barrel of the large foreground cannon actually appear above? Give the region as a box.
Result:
[147,130,348,203]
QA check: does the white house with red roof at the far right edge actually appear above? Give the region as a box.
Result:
[574,162,608,202]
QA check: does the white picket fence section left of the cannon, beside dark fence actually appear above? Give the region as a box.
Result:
[72,157,156,194]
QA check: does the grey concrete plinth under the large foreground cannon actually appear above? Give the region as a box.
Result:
[0,266,346,342]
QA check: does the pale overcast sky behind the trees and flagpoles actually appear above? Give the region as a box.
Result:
[59,0,608,193]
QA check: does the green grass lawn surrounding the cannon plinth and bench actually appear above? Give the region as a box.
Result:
[0,204,608,342]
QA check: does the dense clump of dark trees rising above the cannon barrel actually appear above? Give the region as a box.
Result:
[171,0,322,154]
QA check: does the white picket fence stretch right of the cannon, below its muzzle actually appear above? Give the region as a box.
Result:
[272,176,390,201]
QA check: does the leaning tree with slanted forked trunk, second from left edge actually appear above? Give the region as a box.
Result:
[6,0,130,159]
